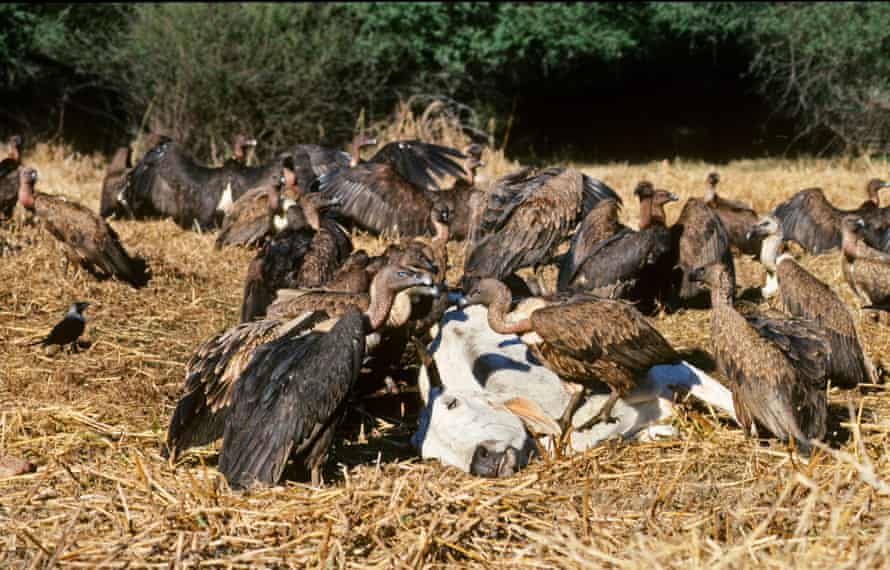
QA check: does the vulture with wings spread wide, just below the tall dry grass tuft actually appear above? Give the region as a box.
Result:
[319,140,464,236]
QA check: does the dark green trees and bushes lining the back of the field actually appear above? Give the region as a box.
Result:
[0,2,890,158]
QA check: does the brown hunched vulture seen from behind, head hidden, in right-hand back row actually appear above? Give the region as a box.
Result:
[671,194,735,304]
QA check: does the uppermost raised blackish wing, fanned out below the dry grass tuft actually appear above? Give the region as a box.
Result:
[368,140,466,190]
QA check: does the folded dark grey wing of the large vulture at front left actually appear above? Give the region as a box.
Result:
[219,307,365,487]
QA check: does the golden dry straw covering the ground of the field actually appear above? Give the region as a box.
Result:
[0,139,890,568]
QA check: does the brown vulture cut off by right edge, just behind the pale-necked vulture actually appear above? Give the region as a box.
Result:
[841,216,890,310]
